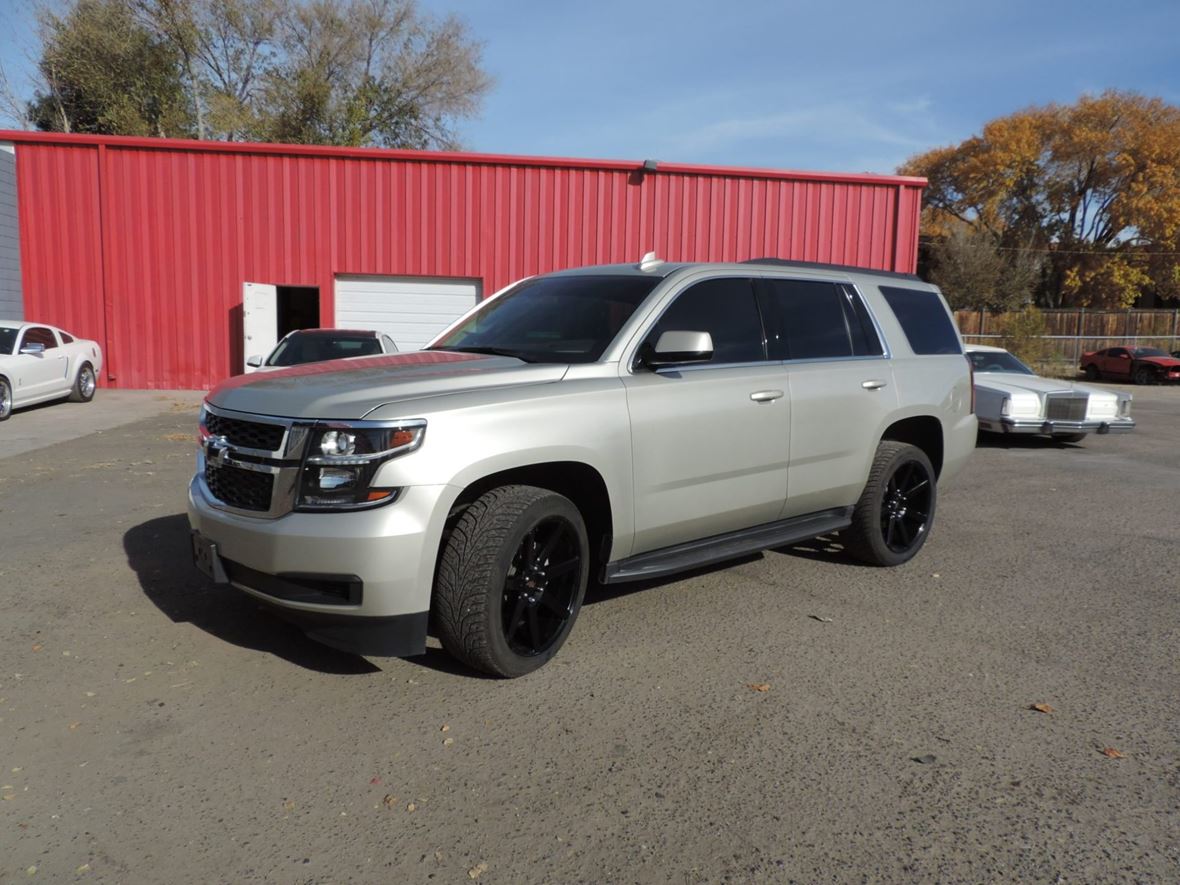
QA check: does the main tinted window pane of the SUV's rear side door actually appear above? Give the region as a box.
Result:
[762,280,852,360]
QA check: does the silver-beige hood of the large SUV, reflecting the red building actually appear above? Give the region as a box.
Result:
[207,350,569,420]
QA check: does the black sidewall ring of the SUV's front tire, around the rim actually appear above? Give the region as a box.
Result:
[476,492,590,676]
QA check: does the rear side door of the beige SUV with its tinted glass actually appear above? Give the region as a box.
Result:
[759,277,898,518]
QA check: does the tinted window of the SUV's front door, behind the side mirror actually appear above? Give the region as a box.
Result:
[647,278,766,363]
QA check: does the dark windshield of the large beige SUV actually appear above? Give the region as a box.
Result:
[430,276,660,362]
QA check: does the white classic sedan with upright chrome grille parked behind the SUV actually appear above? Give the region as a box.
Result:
[966,345,1135,443]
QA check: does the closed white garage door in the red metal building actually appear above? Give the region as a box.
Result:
[336,276,480,350]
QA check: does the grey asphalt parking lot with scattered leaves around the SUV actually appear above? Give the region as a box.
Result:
[0,388,1180,883]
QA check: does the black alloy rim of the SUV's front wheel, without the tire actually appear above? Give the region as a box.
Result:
[500,516,582,657]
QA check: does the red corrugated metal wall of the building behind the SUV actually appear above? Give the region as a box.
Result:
[11,133,923,388]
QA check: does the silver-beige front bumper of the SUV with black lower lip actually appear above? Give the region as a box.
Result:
[189,476,458,656]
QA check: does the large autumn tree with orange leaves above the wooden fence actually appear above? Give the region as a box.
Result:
[898,91,1180,308]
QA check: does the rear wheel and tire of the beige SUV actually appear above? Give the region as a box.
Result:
[844,440,938,565]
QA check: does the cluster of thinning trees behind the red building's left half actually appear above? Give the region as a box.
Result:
[30,0,491,149]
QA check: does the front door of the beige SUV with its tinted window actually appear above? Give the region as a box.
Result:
[623,277,791,553]
